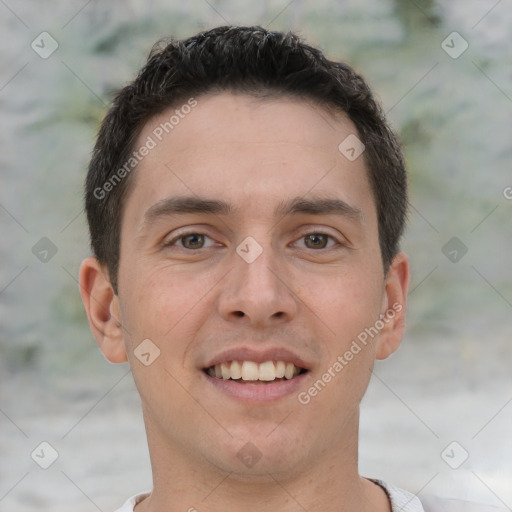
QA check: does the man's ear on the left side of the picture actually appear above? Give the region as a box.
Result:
[79,257,127,363]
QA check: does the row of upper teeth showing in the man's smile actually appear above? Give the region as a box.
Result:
[207,361,301,382]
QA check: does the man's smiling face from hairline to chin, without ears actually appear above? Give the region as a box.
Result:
[111,93,403,478]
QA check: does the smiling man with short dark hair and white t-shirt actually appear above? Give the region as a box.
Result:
[80,27,484,512]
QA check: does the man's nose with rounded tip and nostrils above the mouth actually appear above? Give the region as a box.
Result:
[218,240,298,327]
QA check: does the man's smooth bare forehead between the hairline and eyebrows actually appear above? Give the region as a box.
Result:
[122,92,373,224]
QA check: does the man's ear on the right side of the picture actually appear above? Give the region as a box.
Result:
[376,252,410,359]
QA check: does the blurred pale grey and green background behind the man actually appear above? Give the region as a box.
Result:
[0,0,512,512]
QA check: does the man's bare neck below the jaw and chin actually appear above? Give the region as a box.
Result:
[135,412,390,512]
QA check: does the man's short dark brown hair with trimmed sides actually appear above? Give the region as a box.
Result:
[85,26,407,293]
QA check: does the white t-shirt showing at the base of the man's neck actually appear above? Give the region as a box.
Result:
[115,479,508,512]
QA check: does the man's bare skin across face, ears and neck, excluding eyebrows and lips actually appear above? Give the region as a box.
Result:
[80,92,409,512]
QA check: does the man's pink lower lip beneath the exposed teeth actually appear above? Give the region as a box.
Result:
[201,372,309,402]
